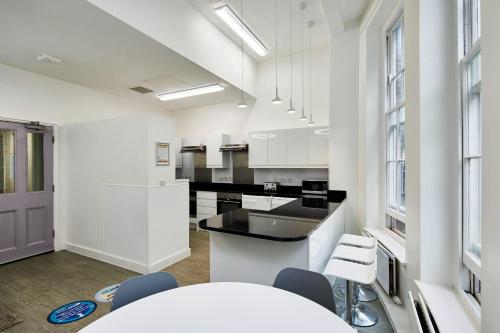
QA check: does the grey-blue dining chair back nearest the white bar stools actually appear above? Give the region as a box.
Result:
[273,267,336,313]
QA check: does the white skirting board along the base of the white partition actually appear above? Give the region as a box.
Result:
[65,243,191,274]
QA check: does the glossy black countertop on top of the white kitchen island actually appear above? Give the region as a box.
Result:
[199,196,344,242]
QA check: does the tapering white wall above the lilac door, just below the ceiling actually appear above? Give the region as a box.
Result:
[0,64,170,125]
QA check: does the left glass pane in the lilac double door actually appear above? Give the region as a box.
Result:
[0,130,16,193]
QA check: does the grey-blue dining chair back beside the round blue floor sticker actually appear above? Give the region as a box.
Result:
[110,272,178,311]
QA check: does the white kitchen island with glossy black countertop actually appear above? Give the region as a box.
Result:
[199,196,344,285]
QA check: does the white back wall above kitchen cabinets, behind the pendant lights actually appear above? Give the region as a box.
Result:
[172,48,330,137]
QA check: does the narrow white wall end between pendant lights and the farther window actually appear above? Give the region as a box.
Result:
[329,29,359,233]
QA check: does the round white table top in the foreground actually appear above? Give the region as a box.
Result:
[80,282,356,333]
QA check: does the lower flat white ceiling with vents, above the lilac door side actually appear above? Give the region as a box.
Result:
[0,0,239,109]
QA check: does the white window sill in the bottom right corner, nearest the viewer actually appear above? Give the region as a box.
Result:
[415,281,480,333]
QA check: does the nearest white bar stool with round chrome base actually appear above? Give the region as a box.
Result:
[323,259,378,327]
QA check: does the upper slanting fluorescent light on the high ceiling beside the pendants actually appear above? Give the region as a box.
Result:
[214,5,269,57]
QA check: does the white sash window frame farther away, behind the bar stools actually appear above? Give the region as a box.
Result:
[384,10,406,238]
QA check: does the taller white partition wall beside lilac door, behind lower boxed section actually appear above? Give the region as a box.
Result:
[62,116,177,249]
